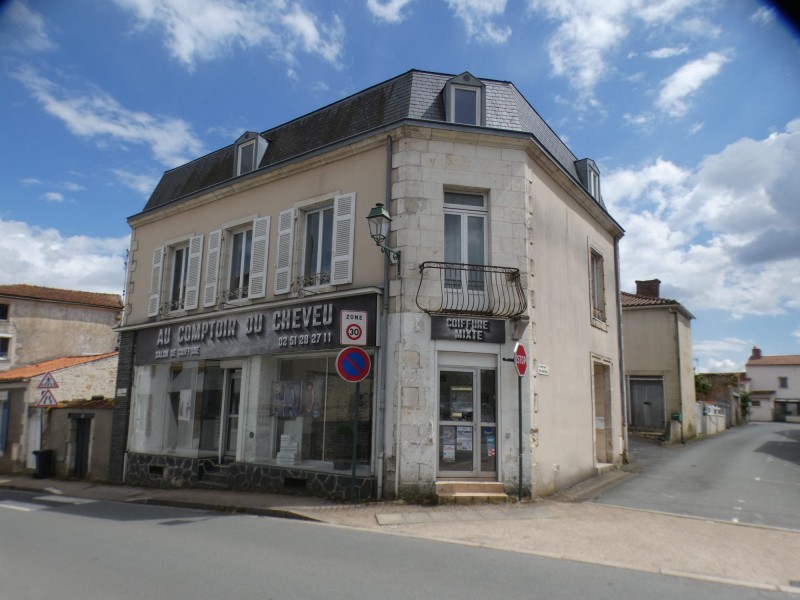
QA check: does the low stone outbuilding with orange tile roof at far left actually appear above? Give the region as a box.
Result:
[0,352,117,479]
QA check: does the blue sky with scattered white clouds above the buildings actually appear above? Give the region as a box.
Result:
[0,0,800,371]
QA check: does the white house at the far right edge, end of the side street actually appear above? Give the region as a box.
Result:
[745,346,800,422]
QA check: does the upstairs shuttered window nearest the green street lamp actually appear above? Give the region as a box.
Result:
[274,194,356,294]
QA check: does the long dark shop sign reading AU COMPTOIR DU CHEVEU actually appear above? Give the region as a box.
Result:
[136,295,377,366]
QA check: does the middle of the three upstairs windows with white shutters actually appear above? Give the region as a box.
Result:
[203,217,270,307]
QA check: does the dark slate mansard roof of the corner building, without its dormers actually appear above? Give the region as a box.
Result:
[143,70,605,218]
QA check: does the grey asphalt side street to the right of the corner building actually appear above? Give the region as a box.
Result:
[596,423,800,528]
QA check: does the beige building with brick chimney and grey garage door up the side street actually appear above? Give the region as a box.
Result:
[621,279,698,441]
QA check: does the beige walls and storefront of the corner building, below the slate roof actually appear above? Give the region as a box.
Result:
[112,70,625,498]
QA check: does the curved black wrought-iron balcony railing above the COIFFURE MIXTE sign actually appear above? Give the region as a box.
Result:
[417,261,528,319]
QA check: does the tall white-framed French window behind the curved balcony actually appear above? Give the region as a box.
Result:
[444,192,487,291]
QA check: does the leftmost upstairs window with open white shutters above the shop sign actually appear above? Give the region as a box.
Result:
[147,235,203,317]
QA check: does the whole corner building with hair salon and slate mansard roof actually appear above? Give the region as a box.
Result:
[110,70,625,499]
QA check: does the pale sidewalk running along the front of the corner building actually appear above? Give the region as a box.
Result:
[0,471,800,595]
